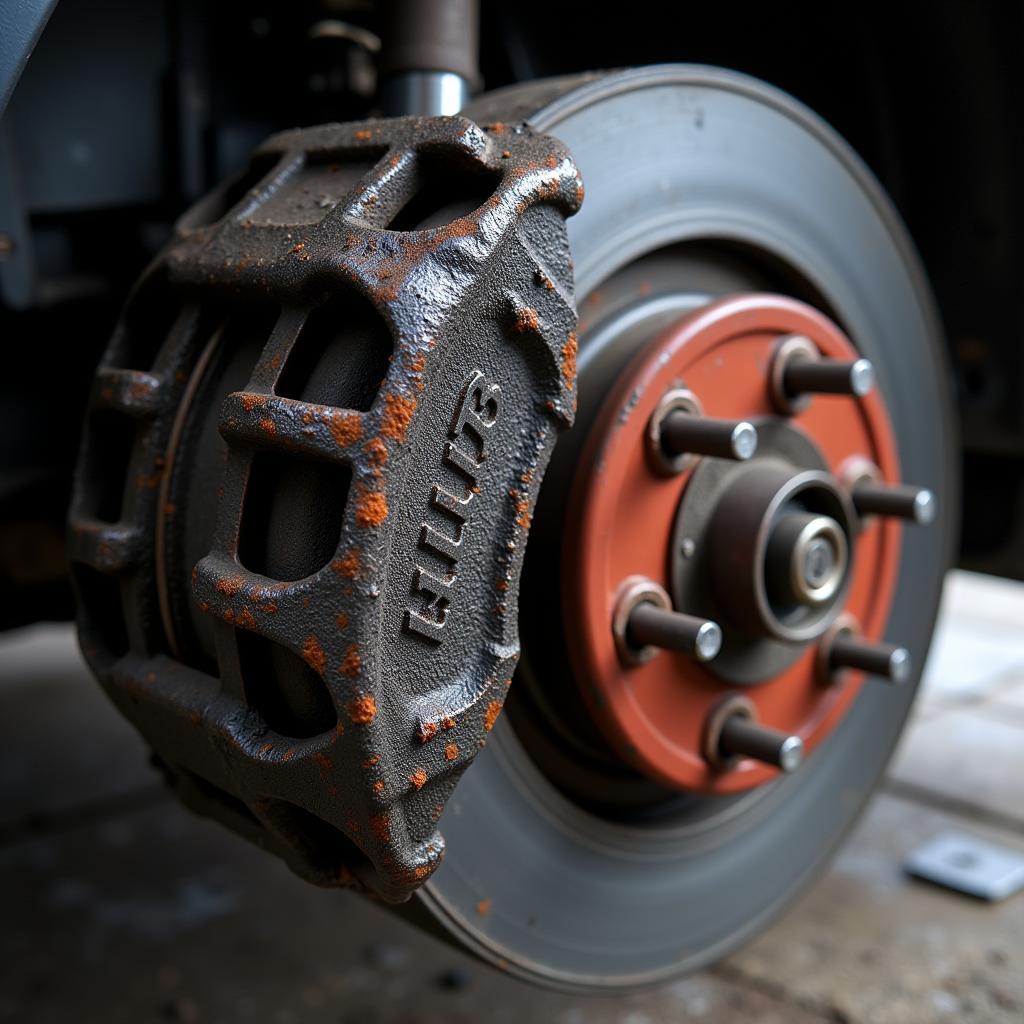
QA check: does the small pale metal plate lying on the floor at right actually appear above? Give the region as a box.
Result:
[904,833,1024,902]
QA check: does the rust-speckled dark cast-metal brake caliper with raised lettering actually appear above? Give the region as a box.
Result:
[70,112,583,902]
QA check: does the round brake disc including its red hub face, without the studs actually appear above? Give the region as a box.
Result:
[418,67,957,991]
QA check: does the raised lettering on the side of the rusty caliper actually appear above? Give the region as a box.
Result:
[404,370,502,644]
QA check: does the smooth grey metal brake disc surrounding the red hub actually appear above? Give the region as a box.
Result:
[418,67,957,991]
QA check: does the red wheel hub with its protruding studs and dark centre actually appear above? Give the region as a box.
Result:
[563,294,925,794]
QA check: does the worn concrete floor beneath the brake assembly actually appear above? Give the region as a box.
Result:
[0,573,1024,1024]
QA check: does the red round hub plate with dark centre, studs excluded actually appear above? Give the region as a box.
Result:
[563,295,900,794]
